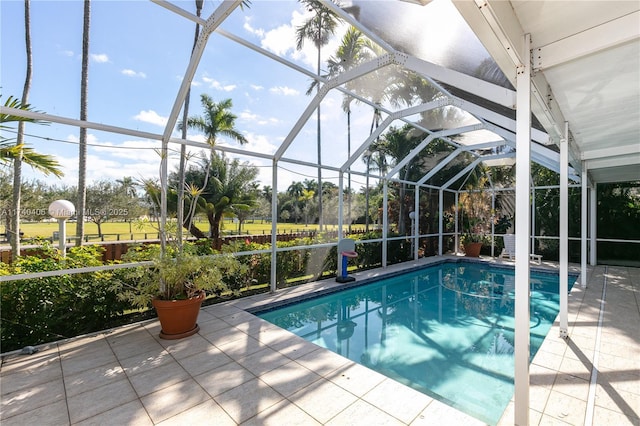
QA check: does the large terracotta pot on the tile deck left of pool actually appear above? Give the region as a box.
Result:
[152,291,205,339]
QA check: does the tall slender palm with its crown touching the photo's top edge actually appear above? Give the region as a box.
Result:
[296,0,340,231]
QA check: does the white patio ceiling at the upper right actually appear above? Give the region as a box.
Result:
[454,0,640,183]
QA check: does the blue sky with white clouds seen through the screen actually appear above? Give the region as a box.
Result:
[0,0,380,190]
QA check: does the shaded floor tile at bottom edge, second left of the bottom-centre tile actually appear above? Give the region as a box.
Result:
[140,379,210,423]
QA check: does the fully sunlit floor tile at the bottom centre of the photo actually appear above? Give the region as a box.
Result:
[289,379,360,423]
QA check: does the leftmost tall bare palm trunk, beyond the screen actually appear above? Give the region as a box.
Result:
[7,0,33,261]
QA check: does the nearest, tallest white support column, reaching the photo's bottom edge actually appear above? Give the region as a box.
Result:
[514,34,531,426]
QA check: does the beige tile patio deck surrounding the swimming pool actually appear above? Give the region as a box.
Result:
[0,259,640,426]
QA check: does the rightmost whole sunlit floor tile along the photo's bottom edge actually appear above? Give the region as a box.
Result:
[362,379,433,423]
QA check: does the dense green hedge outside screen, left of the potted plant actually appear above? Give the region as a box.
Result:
[0,242,129,352]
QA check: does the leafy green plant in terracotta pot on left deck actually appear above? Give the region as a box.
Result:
[114,246,246,339]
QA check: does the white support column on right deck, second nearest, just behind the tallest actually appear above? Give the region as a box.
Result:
[559,123,569,339]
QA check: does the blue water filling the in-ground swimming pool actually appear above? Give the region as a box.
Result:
[257,262,575,424]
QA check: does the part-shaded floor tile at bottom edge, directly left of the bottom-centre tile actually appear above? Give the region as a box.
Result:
[214,378,284,423]
